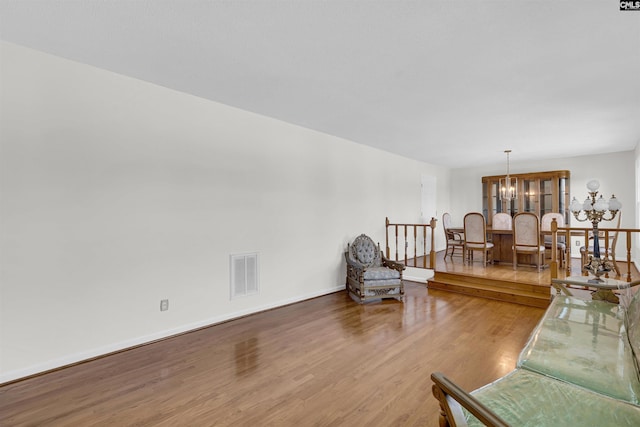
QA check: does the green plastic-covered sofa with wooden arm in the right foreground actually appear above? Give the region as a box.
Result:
[431,292,640,427]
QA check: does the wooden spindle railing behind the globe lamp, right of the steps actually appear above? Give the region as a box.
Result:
[550,219,640,282]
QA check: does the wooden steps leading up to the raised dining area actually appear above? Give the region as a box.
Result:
[427,272,551,308]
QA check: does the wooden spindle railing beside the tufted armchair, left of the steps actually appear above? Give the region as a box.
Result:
[385,218,437,268]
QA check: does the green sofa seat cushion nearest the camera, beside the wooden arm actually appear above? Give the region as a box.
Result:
[465,369,640,427]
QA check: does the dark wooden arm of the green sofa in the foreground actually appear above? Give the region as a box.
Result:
[431,372,509,427]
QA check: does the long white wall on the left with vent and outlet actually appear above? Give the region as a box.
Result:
[0,43,449,383]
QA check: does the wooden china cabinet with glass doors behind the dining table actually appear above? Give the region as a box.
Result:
[482,171,571,225]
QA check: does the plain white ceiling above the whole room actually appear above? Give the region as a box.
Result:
[0,0,640,168]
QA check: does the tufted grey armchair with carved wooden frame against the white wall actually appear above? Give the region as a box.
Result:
[344,234,405,304]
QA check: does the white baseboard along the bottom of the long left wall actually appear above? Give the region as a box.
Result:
[0,285,344,385]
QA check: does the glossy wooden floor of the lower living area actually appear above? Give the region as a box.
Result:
[0,282,544,427]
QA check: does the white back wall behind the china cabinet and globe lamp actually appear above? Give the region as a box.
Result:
[450,150,636,258]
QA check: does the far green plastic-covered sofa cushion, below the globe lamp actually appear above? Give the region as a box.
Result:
[517,296,640,405]
